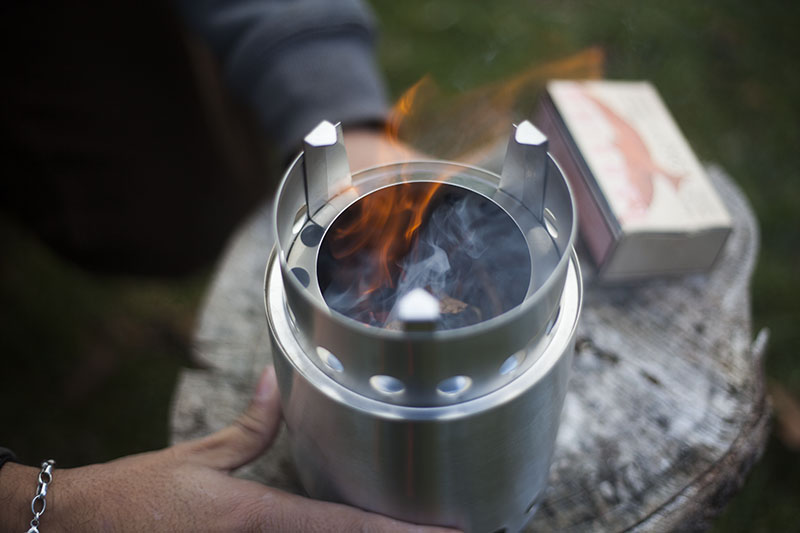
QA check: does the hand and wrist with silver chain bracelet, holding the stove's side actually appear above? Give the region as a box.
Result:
[0,367,460,533]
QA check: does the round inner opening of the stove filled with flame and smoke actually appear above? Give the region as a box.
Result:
[317,182,532,329]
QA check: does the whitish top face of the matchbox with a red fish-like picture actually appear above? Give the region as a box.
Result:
[548,81,730,232]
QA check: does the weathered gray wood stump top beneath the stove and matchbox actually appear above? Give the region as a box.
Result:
[171,166,769,532]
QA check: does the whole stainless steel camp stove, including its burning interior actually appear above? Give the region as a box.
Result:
[265,122,582,533]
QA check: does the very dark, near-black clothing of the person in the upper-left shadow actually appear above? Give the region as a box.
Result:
[0,0,275,274]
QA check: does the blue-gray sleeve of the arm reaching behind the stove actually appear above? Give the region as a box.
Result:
[178,0,387,155]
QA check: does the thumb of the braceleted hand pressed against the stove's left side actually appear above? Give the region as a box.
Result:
[183,366,281,471]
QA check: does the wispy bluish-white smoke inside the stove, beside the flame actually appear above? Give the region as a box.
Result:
[323,187,531,329]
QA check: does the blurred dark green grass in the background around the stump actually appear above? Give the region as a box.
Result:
[0,0,800,532]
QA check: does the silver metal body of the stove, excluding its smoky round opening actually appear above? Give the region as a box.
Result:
[265,123,582,533]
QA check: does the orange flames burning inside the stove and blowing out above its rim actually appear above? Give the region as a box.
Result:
[331,48,604,294]
